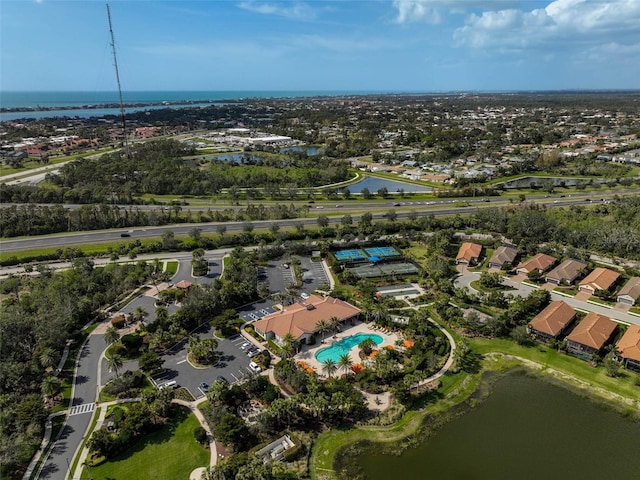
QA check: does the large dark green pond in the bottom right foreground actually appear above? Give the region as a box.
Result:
[358,373,640,480]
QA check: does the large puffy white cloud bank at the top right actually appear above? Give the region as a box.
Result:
[454,0,640,53]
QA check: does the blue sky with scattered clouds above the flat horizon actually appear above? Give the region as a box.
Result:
[0,0,640,92]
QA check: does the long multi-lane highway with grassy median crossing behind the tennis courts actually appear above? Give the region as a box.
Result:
[0,198,608,253]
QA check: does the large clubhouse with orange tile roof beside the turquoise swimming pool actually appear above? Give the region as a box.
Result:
[252,295,360,344]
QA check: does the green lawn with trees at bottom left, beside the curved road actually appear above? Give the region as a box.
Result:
[81,407,209,480]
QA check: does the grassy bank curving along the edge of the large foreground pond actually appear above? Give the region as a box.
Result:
[310,338,640,480]
